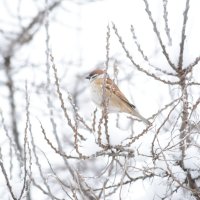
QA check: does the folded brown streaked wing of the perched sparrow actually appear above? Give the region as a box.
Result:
[105,78,136,109]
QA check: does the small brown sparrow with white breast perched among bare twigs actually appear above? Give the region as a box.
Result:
[86,69,150,125]
